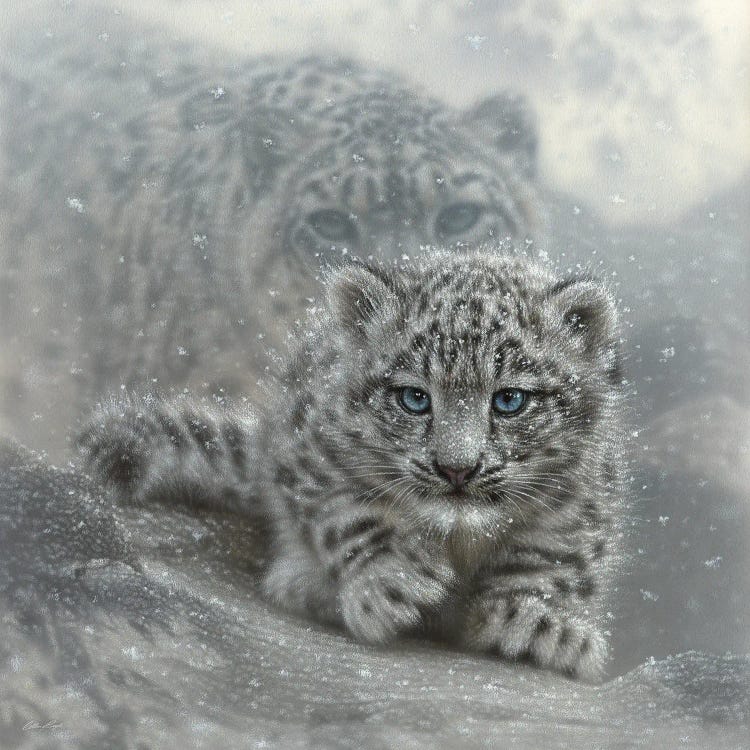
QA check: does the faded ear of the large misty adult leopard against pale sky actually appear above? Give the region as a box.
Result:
[463,93,538,177]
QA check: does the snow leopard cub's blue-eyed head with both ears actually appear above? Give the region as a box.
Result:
[334,254,619,533]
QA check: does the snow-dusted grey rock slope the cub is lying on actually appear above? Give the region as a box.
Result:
[0,445,750,750]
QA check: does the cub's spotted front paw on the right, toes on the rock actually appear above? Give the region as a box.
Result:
[467,596,607,681]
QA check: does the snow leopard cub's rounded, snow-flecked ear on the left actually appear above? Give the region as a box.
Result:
[328,263,399,340]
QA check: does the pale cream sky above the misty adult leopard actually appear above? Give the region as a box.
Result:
[0,0,750,224]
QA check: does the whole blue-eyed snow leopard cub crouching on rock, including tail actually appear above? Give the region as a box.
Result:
[79,251,621,679]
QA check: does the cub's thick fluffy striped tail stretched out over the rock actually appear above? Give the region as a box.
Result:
[76,396,255,510]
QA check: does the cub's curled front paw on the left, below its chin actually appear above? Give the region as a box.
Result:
[339,556,454,644]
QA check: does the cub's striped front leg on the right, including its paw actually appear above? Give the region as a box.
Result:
[465,550,607,680]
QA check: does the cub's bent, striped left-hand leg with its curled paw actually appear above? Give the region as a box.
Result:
[264,495,455,644]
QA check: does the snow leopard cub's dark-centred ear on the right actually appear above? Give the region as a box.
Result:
[547,278,620,378]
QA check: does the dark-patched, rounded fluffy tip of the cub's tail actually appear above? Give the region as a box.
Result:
[76,404,169,495]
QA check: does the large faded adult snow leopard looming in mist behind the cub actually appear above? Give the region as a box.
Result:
[0,17,544,455]
